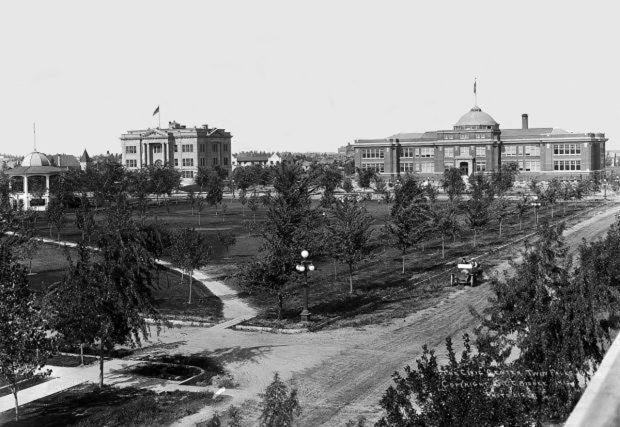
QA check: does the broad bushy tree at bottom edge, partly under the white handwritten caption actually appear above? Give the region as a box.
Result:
[376,334,533,427]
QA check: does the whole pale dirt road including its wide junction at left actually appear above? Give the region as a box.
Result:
[162,202,620,427]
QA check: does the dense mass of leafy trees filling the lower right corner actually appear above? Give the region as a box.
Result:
[377,222,620,427]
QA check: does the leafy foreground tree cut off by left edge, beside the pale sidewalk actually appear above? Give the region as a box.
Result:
[0,244,51,421]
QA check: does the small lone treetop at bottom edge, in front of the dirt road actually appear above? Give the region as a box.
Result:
[259,372,301,427]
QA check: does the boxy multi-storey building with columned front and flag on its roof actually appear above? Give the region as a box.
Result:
[120,122,232,184]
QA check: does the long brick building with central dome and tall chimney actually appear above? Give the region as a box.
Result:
[353,106,607,179]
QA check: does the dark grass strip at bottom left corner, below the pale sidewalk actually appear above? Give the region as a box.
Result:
[0,384,213,427]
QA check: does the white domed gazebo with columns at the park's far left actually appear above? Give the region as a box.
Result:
[6,151,65,211]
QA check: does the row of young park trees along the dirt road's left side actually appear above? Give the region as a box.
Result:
[239,160,604,318]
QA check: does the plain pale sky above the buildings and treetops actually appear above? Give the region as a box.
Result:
[0,0,620,154]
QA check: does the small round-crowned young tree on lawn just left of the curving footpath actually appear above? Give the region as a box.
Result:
[170,228,211,304]
